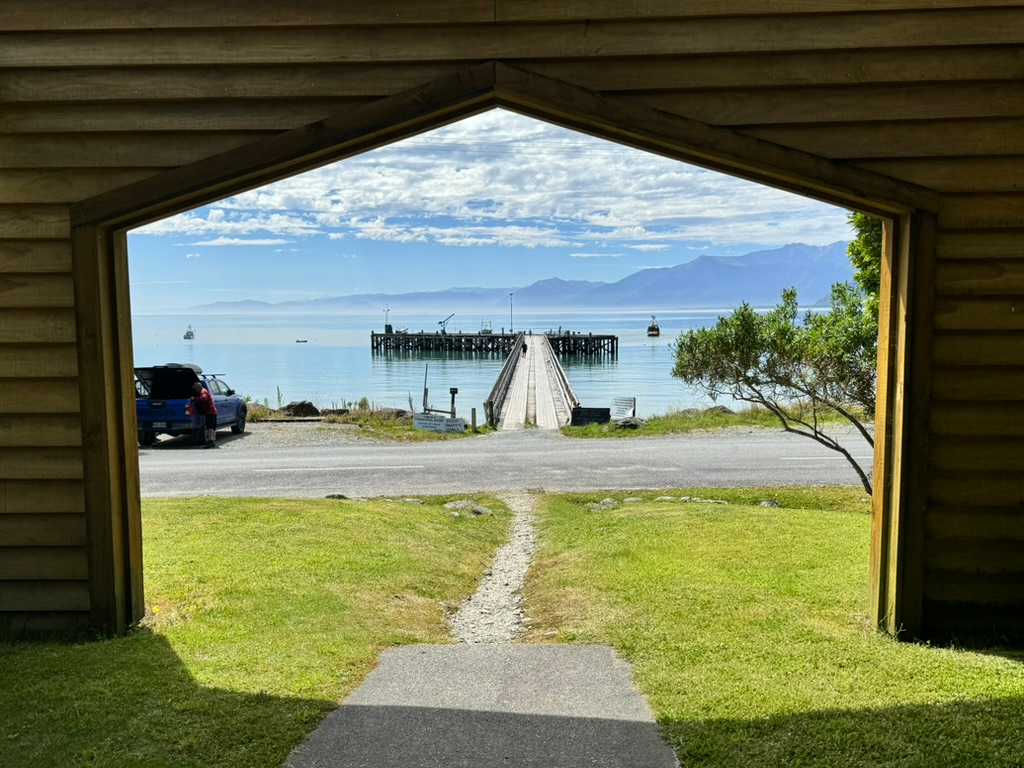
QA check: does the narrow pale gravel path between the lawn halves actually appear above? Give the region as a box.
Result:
[450,493,537,643]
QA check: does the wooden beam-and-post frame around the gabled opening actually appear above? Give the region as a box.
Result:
[72,62,936,631]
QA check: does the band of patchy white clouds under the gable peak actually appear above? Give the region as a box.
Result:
[132,111,850,251]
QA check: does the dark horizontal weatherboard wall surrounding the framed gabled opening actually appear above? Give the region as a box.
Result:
[0,0,1024,637]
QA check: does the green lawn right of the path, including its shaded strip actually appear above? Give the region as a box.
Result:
[526,488,1024,768]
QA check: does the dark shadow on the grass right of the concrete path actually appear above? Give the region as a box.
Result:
[659,698,1024,768]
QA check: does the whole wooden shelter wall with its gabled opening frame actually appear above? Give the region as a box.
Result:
[0,0,1024,638]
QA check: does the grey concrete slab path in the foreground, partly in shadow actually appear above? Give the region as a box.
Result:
[285,645,678,768]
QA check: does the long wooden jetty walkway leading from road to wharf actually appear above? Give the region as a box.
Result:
[498,335,577,430]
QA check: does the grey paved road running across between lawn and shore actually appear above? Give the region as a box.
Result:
[139,429,870,498]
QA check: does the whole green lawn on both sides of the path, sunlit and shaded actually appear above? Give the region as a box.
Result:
[0,488,1024,768]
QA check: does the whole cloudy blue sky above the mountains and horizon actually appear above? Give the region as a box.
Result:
[129,111,851,312]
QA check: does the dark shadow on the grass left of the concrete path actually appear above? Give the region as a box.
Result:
[0,631,336,768]
